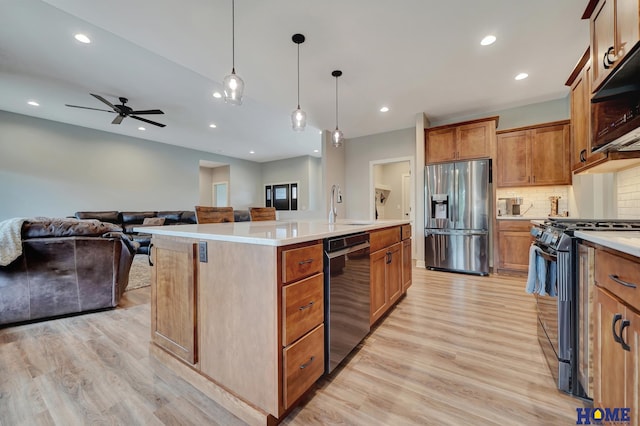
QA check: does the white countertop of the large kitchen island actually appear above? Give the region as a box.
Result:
[133,219,410,246]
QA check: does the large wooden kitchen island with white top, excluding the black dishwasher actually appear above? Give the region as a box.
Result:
[136,220,411,424]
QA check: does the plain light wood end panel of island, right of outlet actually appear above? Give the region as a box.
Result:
[198,241,280,417]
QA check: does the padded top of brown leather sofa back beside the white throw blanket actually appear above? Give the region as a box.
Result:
[22,217,122,239]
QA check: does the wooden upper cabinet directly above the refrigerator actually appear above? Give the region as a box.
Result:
[425,117,498,164]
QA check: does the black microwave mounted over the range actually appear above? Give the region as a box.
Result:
[591,43,640,152]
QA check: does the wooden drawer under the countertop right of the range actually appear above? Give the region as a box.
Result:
[595,250,640,309]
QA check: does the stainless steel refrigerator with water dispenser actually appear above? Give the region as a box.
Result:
[424,160,491,275]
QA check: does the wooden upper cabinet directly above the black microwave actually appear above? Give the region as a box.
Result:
[582,0,640,92]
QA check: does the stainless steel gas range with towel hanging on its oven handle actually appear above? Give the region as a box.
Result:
[529,218,640,399]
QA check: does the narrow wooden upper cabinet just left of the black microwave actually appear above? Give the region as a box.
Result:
[565,48,605,171]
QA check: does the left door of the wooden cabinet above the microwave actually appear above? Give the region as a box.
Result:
[591,0,616,91]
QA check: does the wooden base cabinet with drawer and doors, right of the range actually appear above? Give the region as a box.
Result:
[593,246,640,424]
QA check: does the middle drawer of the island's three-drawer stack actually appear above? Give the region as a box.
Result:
[282,274,324,346]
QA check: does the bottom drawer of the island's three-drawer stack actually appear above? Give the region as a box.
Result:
[283,324,324,409]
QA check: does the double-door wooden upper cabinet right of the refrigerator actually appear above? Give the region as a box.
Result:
[494,120,571,187]
